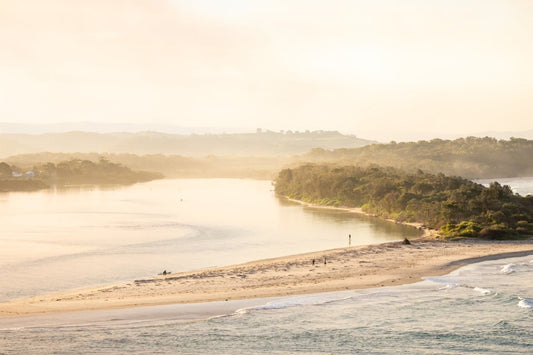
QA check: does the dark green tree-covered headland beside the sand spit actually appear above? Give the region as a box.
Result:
[276,164,533,238]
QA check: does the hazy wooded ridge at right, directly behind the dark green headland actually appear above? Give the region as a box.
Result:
[302,137,533,179]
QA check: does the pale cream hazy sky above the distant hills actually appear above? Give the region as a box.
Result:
[0,0,533,139]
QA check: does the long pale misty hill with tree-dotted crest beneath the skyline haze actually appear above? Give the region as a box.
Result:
[0,130,375,158]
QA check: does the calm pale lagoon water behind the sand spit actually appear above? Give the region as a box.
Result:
[0,179,418,300]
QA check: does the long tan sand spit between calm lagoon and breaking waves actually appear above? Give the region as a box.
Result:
[0,236,533,317]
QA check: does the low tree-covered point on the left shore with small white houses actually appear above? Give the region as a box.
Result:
[0,158,162,192]
